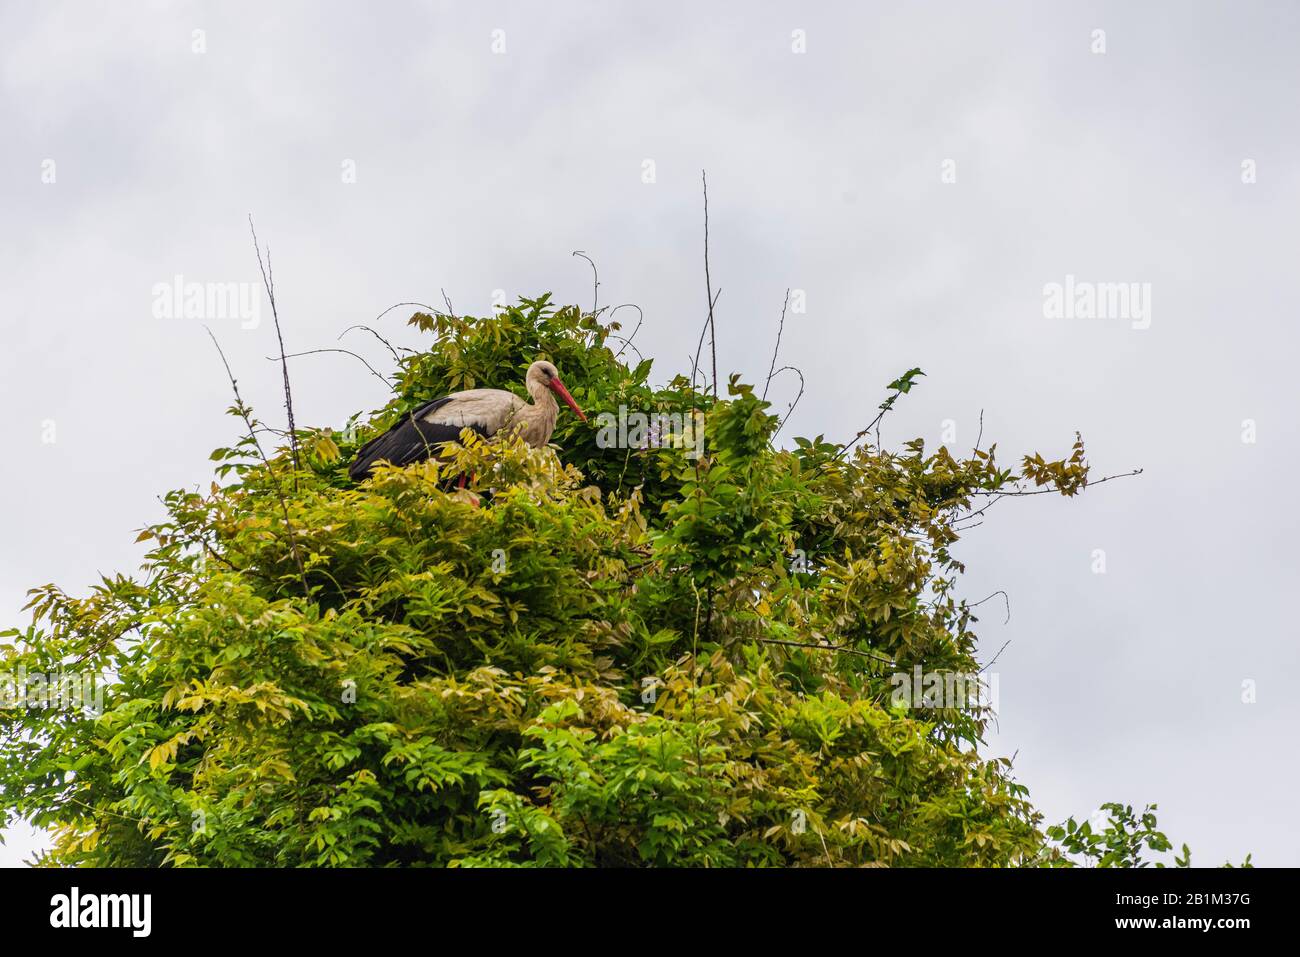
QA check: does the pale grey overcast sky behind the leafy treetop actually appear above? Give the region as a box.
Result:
[0,0,1300,866]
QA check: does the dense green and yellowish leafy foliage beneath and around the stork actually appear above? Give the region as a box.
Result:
[0,298,1216,866]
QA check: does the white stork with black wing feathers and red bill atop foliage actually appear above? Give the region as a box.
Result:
[347,360,586,486]
